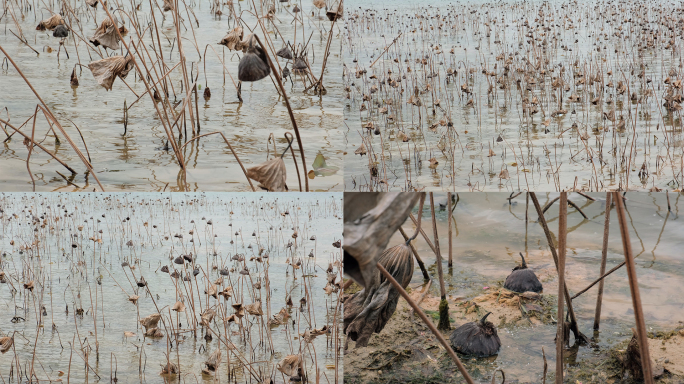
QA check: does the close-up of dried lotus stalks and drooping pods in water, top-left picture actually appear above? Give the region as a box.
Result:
[0,0,344,192]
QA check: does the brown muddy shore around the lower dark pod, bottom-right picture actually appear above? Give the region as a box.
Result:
[344,282,684,384]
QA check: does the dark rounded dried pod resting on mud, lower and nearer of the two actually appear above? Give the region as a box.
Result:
[449,312,501,357]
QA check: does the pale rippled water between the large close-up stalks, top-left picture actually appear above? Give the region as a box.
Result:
[0,0,344,191]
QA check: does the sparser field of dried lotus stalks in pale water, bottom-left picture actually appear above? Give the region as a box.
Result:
[0,193,342,383]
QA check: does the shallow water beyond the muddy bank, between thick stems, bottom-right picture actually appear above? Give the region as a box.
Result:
[376,193,684,382]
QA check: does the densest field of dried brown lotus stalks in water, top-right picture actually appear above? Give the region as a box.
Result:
[343,0,684,191]
